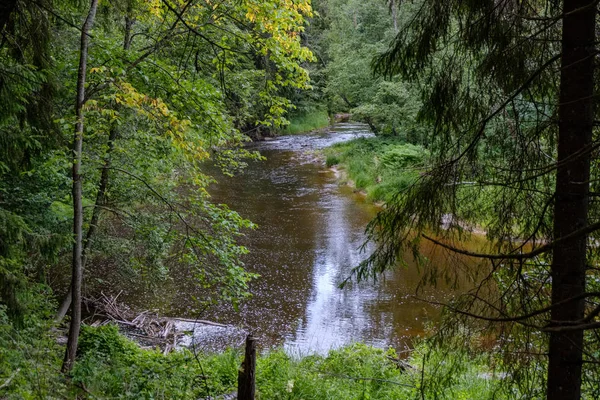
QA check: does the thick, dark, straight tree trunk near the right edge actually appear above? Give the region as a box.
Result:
[547,0,596,400]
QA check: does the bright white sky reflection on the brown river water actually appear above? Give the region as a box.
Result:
[285,174,385,354]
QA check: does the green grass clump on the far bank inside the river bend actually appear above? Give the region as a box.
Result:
[325,137,429,202]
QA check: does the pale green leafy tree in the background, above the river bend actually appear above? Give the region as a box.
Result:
[309,0,427,144]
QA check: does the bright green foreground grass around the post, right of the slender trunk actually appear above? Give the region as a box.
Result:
[73,326,510,400]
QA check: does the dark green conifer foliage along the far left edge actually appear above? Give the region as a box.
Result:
[0,1,70,325]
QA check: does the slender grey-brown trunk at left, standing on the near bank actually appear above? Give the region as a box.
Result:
[62,0,98,373]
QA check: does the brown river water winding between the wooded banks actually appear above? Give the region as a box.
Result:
[117,124,488,355]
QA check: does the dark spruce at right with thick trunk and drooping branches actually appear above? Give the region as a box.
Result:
[356,0,600,399]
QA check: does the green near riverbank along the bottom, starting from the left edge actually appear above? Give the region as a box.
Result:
[0,292,510,400]
